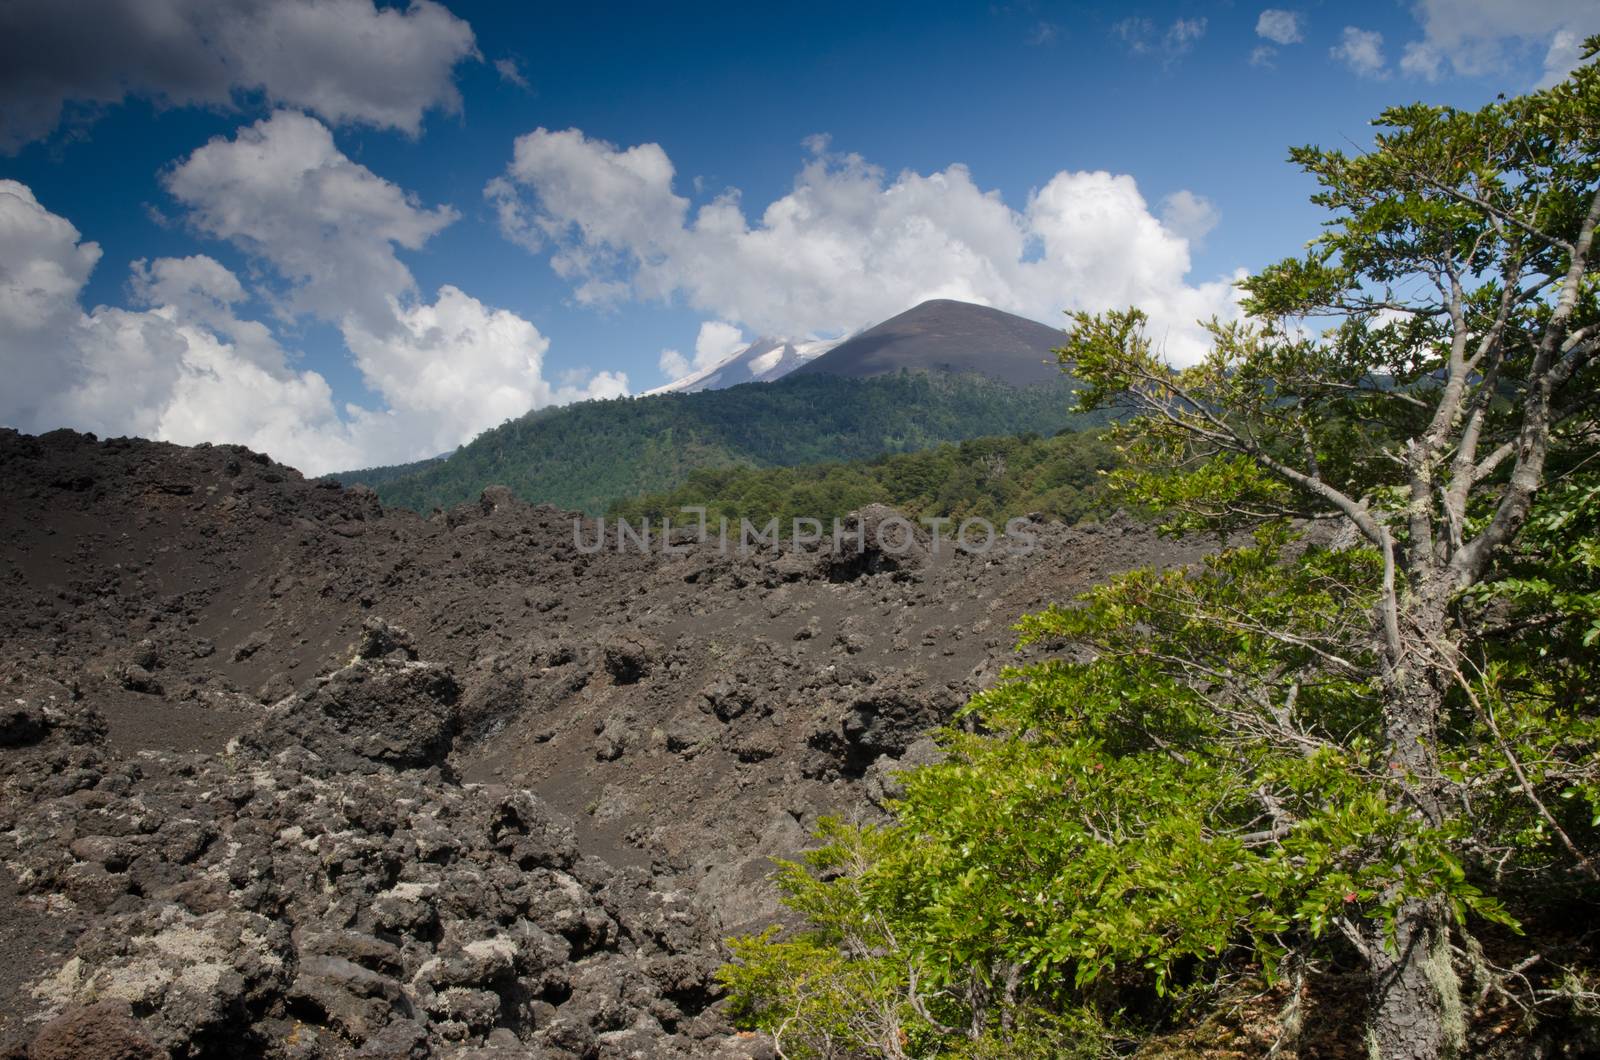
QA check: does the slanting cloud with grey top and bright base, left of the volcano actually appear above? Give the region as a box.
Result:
[165,112,627,461]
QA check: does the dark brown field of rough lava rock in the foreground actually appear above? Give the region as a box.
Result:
[0,432,1198,1060]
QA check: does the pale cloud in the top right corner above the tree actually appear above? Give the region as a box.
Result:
[1400,0,1600,86]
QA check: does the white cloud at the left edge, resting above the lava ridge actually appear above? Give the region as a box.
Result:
[0,181,358,469]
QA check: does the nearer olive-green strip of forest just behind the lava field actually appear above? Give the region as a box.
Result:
[611,431,1115,525]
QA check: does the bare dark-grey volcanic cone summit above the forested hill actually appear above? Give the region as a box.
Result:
[795,298,1062,386]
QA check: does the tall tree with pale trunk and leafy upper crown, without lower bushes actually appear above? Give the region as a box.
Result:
[1064,43,1600,1057]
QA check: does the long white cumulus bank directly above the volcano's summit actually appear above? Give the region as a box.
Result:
[490,128,1235,375]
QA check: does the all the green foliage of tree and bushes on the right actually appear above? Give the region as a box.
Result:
[730,38,1600,1057]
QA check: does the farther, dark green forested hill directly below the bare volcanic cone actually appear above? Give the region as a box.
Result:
[334,371,1106,514]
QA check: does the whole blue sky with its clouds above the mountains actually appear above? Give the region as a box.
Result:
[0,0,1600,471]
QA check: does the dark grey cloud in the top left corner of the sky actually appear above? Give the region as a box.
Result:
[0,0,477,152]
